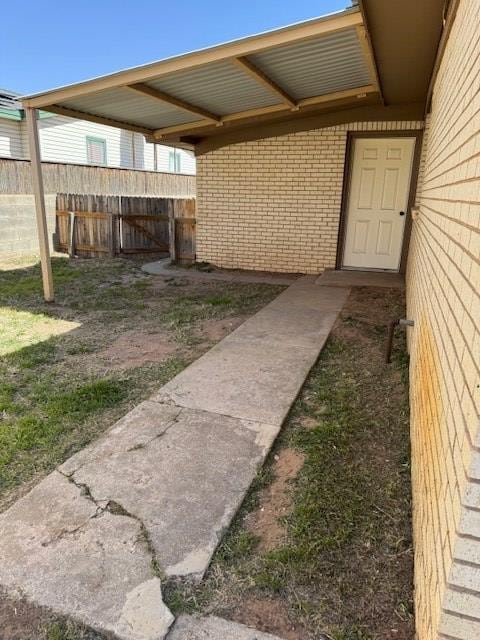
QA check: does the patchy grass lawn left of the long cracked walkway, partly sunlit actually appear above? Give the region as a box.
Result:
[0,258,284,640]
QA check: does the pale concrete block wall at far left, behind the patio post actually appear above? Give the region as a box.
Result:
[0,193,56,258]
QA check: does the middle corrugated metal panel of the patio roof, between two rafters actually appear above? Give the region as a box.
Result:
[148,62,279,115]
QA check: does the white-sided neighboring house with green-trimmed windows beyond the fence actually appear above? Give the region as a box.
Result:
[0,89,195,175]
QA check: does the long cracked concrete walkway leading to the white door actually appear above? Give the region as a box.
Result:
[0,277,349,640]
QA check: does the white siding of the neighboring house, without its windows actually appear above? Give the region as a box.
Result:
[0,111,195,175]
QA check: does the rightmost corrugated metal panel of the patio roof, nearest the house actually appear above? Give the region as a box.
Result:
[249,29,371,100]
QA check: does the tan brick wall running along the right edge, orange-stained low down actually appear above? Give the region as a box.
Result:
[407,0,480,640]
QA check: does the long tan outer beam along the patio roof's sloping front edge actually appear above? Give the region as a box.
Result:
[23,8,363,108]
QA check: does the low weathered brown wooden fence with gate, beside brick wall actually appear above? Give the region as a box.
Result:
[54,194,195,263]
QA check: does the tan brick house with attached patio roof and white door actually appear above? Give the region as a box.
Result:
[18,0,480,640]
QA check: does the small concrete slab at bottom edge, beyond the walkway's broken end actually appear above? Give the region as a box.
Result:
[168,615,282,640]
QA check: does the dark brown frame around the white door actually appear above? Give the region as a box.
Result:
[335,129,423,273]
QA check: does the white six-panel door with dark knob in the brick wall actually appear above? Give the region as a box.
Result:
[343,138,415,271]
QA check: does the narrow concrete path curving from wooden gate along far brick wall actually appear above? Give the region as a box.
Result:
[142,258,299,285]
